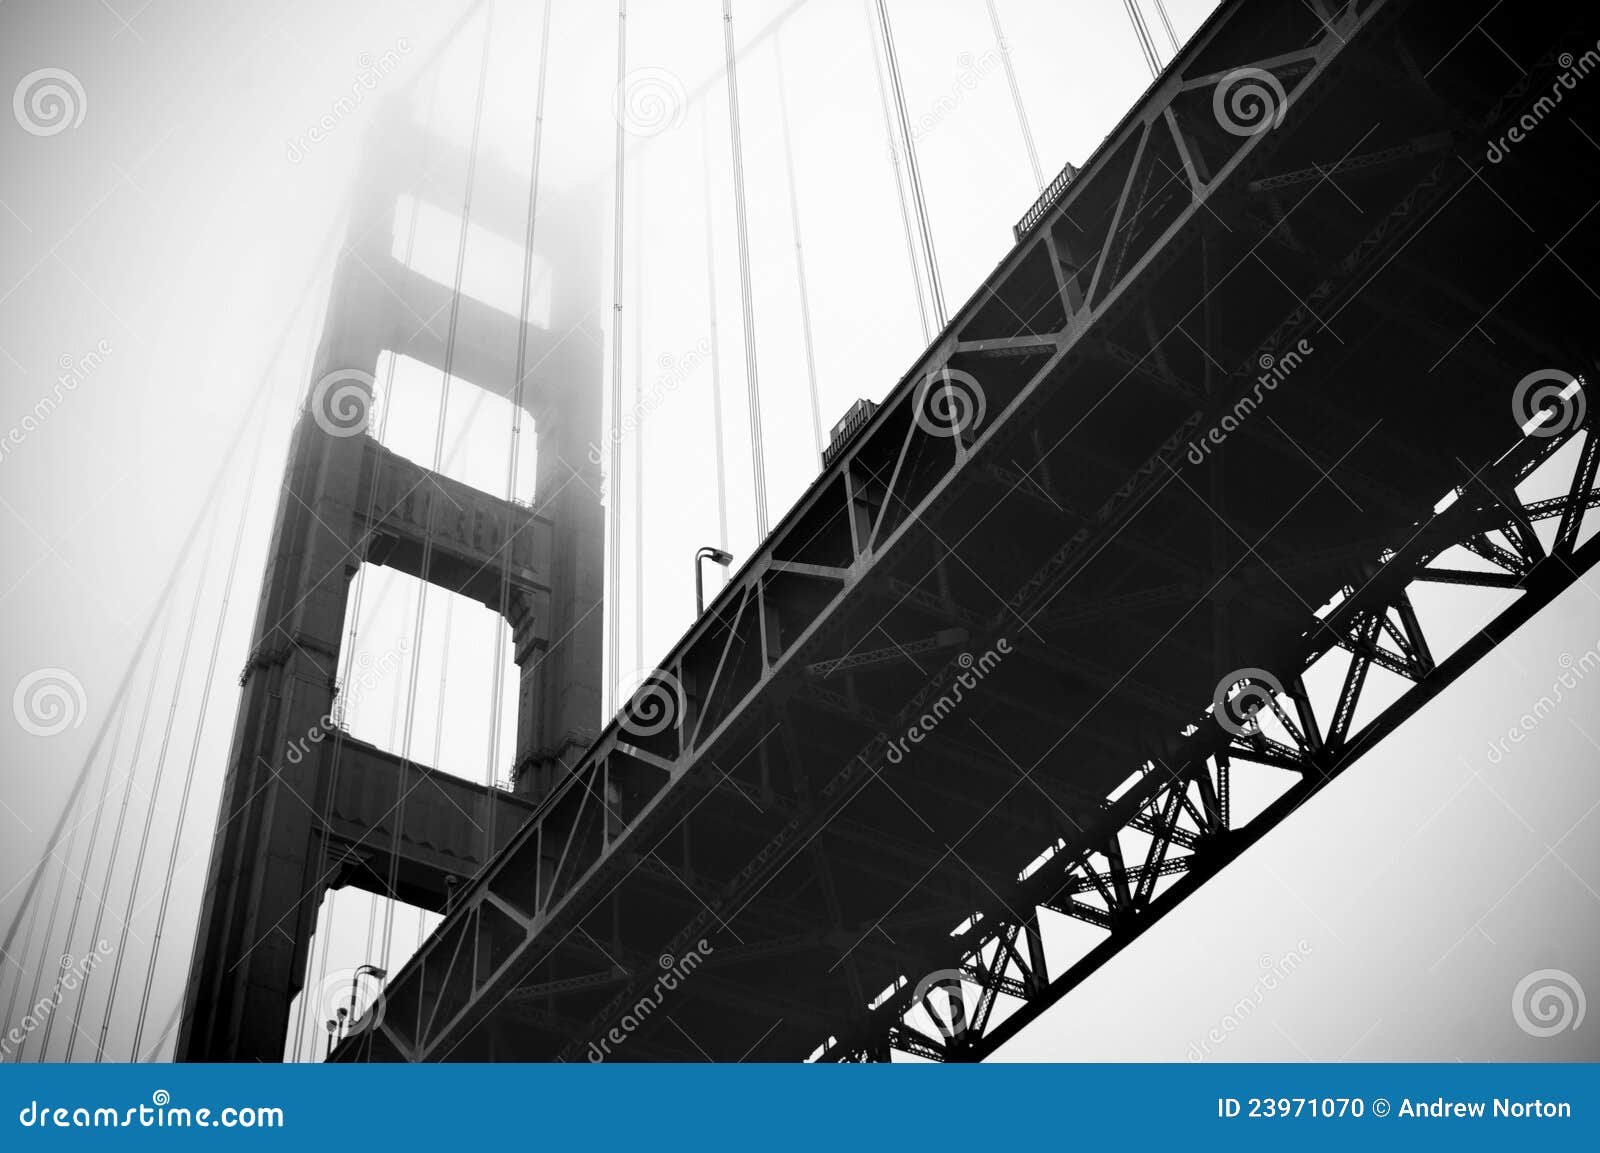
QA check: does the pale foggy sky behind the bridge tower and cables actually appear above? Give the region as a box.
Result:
[0,0,1600,1060]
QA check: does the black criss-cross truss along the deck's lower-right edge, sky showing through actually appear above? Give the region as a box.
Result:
[816,403,1600,1062]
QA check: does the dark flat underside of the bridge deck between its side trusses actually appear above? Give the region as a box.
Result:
[340,5,1600,1060]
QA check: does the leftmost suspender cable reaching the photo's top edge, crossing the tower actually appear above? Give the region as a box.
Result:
[379,0,494,991]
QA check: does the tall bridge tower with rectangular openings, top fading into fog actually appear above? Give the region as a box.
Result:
[176,107,603,1060]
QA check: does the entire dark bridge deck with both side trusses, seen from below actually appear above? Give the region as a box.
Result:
[184,0,1600,1060]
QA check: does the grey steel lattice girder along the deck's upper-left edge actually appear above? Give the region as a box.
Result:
[334,3,1384,1060]
